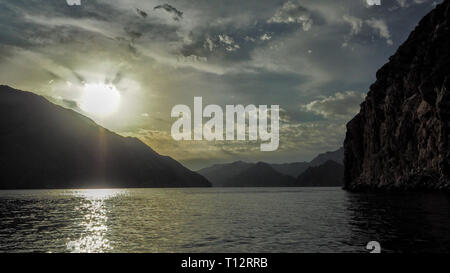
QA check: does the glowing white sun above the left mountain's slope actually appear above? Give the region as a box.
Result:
[80,83,120,117]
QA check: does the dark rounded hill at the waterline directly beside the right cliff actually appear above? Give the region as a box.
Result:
[297,160,344,187]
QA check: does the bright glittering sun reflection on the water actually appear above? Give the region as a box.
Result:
[67,189,127,253]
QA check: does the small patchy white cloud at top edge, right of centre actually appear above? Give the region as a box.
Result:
[267,1,313,31]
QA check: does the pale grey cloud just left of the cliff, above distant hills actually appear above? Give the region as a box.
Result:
[302,91,365,119]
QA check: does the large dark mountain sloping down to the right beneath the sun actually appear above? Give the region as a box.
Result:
[0,86,211,189]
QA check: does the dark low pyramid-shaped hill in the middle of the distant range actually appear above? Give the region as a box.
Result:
[223,162,295,187]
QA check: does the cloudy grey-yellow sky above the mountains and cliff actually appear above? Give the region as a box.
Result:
[0,0,441,170]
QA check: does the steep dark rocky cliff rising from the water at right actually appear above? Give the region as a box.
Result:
[344,0,450,190]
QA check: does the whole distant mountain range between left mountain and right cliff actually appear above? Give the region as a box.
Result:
[198,148,344,187]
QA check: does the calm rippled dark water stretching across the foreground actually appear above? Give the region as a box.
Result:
[0,188,450,252]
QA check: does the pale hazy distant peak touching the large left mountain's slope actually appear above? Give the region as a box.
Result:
[197,161,254,187]
